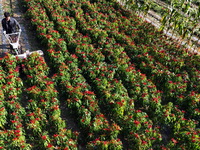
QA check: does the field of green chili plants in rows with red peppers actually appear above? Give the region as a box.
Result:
[0,0,200,150]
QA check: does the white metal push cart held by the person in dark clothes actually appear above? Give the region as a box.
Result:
[4,30,44,59]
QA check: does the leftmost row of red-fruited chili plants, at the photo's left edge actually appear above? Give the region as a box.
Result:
[0,55,31,150]
